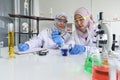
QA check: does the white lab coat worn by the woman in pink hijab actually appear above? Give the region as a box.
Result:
[67,24,97,47]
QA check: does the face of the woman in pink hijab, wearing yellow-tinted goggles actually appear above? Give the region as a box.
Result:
[74,14,88,32]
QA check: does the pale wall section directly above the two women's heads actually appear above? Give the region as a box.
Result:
[39,0,91,22]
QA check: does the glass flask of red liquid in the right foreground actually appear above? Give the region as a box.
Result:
[92,50,118,80]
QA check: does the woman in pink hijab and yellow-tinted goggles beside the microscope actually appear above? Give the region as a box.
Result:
[68,7,97,54]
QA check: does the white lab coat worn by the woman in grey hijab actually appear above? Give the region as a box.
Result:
[26,28,70,49]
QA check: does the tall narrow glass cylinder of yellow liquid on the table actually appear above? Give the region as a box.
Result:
[8,23,14,58]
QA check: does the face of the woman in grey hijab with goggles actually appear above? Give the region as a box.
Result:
[56,16,67,30]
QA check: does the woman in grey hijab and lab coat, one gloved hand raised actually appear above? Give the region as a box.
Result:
[18,13,70,51]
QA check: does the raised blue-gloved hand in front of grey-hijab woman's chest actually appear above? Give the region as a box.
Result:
[52,30,63,46]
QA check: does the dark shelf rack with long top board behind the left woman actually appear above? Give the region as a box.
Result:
[8,14,54,43]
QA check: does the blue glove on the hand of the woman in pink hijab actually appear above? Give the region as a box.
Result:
[69,45,86,55]
